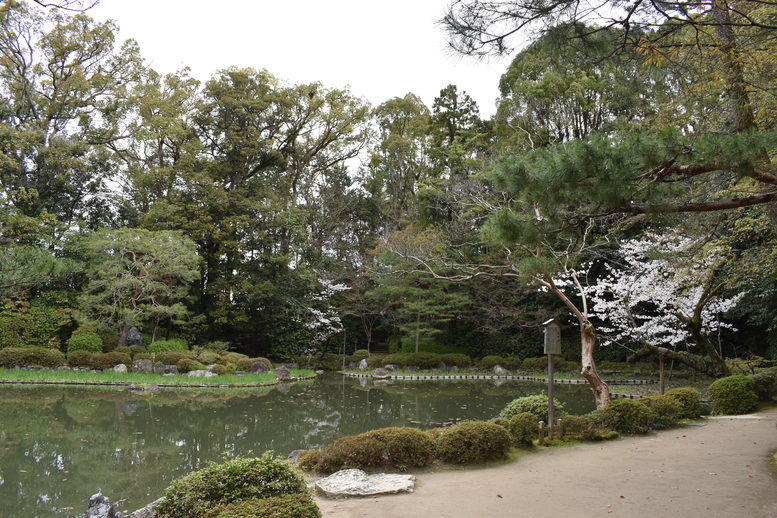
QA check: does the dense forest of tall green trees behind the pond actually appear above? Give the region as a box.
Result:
[0,1,777,373]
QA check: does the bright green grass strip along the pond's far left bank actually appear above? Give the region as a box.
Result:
[0,368,315,387]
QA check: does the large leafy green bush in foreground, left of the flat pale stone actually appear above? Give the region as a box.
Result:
[156,452,307,518]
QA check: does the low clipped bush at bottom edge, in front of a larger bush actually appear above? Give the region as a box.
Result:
[205,493,321,518]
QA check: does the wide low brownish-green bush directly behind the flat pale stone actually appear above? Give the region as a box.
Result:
[299,428,434,473]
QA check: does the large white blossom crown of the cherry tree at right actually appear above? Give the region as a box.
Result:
[584,233,744,346]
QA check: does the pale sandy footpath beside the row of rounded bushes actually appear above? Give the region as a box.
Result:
[317,408,777,518]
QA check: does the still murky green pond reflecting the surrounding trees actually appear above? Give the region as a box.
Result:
[0,374,594,518]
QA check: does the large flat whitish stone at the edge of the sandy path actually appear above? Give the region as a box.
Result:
[316,469,415,498]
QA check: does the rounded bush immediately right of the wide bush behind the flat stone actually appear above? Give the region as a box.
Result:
[435,421,511,464]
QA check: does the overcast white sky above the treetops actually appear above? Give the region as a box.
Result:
[88,0,509,116]
